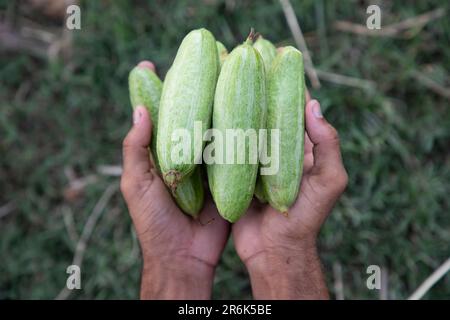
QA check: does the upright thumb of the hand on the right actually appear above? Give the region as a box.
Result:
[305,100,347,188]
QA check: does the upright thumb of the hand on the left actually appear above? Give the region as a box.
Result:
[123,106,152,177]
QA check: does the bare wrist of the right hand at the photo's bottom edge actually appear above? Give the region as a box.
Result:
[245,243,328,299]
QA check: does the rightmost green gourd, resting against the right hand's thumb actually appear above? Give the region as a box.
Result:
[261,46,305,213]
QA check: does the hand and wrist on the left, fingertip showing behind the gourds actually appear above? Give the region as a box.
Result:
[121,62,229,299]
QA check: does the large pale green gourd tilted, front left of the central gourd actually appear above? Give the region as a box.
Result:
[156,29,219,190]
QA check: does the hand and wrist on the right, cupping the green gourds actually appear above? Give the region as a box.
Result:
[232,97,348,299]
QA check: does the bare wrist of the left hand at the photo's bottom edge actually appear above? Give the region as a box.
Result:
[141,257,214,300]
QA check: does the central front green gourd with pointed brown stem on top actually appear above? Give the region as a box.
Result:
[207,33,266,222]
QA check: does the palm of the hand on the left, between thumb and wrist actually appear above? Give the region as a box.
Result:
[129,177,229,265]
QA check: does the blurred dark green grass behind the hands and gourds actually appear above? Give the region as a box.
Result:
[0,0,450,299]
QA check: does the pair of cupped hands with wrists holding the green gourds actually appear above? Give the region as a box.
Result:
[121,62,348,299]
